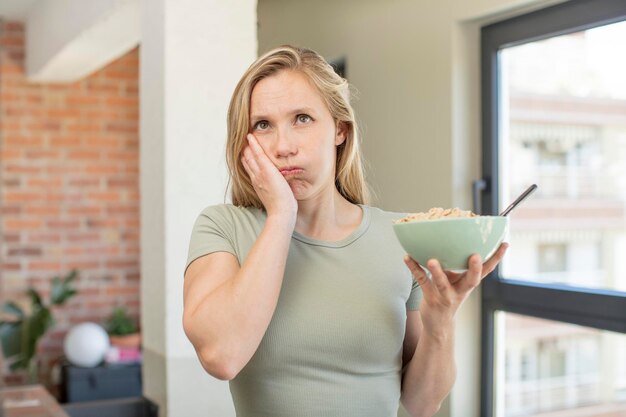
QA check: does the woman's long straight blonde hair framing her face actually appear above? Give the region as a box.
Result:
[226,45,369,209]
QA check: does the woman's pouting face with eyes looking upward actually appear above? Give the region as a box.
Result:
[250,70,345,201]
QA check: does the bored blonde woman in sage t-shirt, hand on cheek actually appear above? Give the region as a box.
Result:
[183,46,506,417]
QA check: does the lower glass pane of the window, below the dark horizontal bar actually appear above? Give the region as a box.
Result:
[495,312,626,417]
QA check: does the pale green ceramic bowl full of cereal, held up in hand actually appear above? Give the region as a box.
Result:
[393,216,509,271]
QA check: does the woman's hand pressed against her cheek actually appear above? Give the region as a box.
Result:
[241,133,298,226]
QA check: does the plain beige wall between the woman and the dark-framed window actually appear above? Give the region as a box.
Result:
[258,0,558,417]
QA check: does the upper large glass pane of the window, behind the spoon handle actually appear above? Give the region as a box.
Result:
[499,22,626,291]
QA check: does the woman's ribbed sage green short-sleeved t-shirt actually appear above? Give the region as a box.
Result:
[187,205,421,417]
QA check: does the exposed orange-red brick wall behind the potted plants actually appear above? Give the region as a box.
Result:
[0,21,140,384]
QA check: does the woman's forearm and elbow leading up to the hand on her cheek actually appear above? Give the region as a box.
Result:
[185,218,293,379]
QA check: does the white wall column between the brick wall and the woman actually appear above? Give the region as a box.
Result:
[140,0,257,417]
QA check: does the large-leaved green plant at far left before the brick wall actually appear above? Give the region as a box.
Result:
[0,270,77,382]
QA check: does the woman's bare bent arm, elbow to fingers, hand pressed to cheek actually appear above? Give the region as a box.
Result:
[183,134,298,379]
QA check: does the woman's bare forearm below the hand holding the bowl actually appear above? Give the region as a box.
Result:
[401,325,456,417]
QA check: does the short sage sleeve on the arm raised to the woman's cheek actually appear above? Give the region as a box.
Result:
[185,205,237,272]
